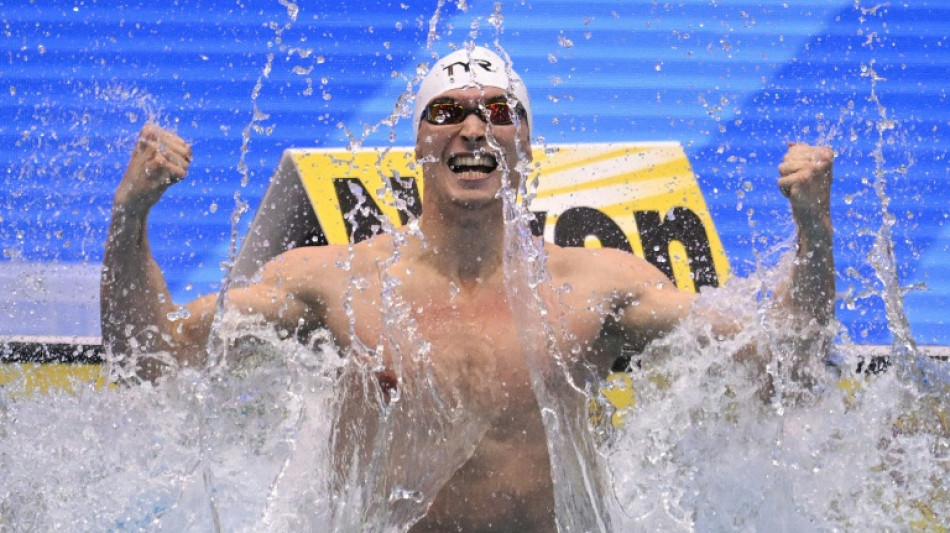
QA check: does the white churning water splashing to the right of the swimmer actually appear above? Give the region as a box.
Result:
[604,268,950,531]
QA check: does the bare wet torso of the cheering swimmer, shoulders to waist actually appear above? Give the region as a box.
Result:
[286,235,648,532]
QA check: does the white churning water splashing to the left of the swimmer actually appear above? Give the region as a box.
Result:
[0,314,338,531]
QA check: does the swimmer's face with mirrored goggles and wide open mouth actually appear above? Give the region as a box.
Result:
[416,87,531,207]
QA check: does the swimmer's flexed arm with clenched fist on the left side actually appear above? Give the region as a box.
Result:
[100,124,316,380]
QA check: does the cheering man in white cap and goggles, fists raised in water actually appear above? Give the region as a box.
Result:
[102,48,835,532]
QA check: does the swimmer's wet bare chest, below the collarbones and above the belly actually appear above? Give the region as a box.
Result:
[329,276,602,402]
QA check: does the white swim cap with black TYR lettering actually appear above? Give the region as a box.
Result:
[412,46,532,131]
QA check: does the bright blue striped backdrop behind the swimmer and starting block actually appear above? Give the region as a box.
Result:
[0,0,950,344]
